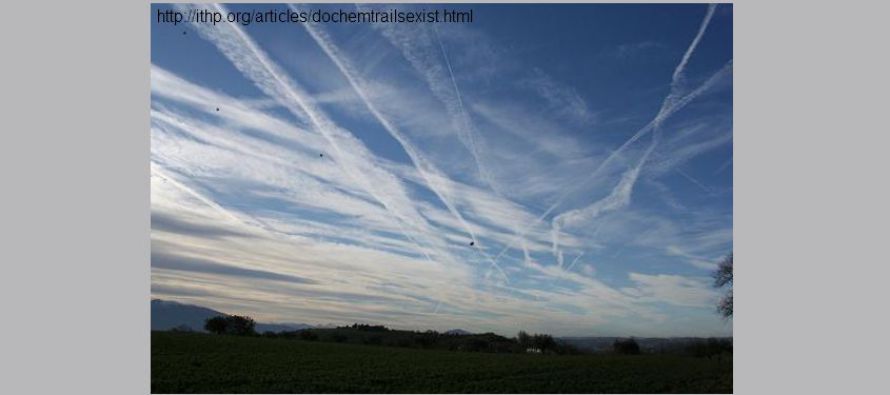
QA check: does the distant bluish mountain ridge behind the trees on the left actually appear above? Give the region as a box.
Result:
[151,299,312,333]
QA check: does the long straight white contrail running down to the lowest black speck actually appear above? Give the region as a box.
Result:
[291,9,509,281]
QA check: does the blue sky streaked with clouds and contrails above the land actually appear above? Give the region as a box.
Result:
[150,4,732,336]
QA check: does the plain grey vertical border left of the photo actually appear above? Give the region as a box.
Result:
[0,1,150,394]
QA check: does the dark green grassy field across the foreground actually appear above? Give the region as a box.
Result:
[151,332,732,393]
